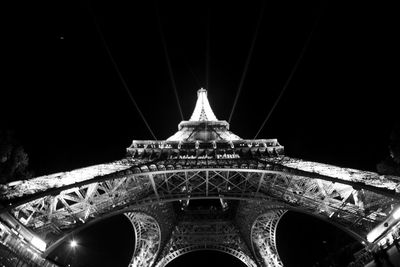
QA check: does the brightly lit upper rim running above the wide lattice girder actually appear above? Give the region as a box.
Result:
[0,157,400,211]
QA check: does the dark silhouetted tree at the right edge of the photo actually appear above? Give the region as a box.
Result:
[377,123,400,176]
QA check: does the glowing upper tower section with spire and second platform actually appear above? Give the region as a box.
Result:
[127,88,283,159]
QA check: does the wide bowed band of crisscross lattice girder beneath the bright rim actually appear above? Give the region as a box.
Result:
[2,169,396,244]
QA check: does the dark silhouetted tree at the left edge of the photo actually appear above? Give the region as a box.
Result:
[0,129,32,184]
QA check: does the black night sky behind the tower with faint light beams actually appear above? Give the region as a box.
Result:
[0,0,399,267]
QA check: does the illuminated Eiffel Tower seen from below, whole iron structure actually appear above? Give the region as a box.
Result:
[0,89,400,267]
